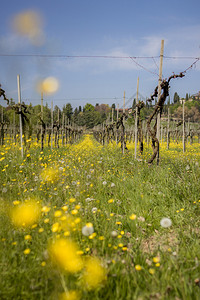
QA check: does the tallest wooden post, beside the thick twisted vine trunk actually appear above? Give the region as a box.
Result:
[157,40,164,165]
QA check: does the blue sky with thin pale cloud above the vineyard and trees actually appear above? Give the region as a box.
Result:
[0,0,200,108]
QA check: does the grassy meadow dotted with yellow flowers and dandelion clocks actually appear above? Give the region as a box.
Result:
[0,134,200,300]
